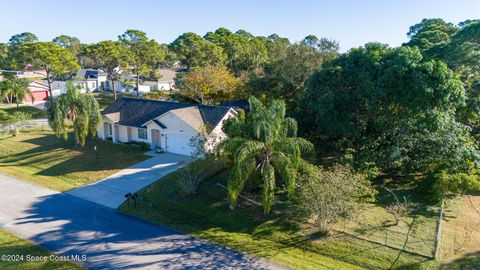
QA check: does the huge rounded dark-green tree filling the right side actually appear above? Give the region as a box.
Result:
[299,43,478,194]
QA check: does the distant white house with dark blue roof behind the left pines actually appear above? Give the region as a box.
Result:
[73,69,110,92]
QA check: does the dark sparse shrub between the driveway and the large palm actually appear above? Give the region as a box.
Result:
[177,158,225,196]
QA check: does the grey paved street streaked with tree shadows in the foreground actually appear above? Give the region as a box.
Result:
[0,175,284,269]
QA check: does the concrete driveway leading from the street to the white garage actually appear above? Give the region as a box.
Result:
[66,151,191,209]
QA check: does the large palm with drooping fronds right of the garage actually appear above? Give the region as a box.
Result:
[221,97,313,214]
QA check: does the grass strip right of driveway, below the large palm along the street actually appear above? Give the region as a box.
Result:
[120,168,438,269]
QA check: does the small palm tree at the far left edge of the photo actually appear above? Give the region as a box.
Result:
[0,74,33,108]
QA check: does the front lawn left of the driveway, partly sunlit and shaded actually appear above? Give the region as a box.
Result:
[0,129,148,191]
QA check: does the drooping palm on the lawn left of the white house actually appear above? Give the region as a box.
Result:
[48,81,101,147]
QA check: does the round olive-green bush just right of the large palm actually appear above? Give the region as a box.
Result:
[293,164,374,233]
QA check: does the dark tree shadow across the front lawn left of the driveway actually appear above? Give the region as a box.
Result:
[0,134,148,176]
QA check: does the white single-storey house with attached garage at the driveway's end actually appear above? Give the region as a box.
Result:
[98,98,237,156]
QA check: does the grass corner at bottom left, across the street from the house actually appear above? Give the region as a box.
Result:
[0,229,83,270]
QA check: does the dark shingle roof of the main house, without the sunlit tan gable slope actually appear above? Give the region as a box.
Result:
[102,97,231,127]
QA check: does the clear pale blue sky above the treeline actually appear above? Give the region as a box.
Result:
[0,0,480,51]
